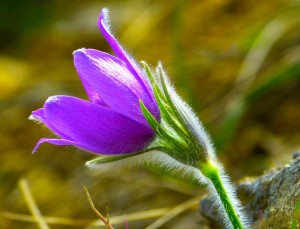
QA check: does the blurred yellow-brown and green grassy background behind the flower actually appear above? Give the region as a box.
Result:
[0,0,300,229]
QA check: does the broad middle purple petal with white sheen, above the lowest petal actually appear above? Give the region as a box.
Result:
[74,49,155,124]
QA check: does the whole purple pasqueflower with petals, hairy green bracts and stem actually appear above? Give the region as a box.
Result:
[32,7,248,229]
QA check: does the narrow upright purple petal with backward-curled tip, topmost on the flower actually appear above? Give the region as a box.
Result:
[98,8,160,121]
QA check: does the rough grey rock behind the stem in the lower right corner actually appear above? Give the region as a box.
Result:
[200,155,300,229]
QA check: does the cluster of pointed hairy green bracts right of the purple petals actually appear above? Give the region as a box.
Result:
[140,62,208,166]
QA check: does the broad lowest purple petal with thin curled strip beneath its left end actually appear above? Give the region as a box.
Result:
[37,96,154,154]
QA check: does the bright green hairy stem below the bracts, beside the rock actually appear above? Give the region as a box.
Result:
[200,161,244,229]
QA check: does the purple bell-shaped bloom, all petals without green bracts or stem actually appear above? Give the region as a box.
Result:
[31,9,160,155]
